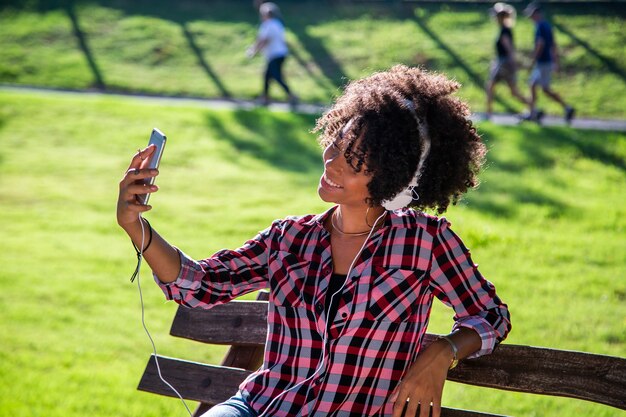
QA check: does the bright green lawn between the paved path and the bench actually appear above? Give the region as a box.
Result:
[0,88,626,417]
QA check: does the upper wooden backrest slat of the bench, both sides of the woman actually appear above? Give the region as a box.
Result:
[171,300,626,409]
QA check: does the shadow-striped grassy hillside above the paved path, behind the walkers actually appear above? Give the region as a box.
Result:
[0,0,626,118]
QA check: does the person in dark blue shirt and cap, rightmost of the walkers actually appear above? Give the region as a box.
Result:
[524,3,575,123]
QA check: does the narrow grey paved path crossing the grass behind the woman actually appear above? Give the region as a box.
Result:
[0,85,626,132]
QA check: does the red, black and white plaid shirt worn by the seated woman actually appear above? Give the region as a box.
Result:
[157,209,511,416]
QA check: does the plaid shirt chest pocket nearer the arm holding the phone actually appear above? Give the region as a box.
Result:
[269,251,310,307]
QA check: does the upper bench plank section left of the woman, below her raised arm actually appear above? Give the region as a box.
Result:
[170,301,267,346]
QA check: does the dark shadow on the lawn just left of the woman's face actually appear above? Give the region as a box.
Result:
[206,109,322,174]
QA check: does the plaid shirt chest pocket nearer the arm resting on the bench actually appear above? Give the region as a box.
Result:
[365,265,428,322]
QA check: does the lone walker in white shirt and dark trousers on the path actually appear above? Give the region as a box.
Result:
[248,2,297,105]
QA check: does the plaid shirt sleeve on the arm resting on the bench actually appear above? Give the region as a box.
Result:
[430,219,511,357]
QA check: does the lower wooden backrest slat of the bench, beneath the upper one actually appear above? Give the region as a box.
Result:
[138,355,502,417]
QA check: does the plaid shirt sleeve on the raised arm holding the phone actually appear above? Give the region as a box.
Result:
[154,223,276,308]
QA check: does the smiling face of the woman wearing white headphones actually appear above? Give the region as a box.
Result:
[317,121,371,207]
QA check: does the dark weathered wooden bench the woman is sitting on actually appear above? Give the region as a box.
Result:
[138,292,626,417]
